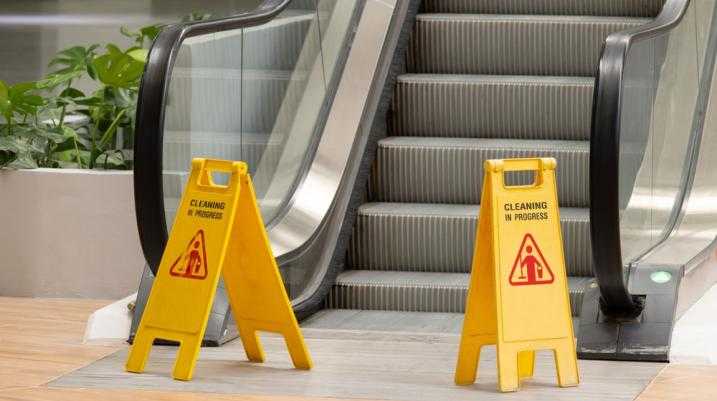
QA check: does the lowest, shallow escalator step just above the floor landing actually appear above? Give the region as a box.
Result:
[326,270,592,316]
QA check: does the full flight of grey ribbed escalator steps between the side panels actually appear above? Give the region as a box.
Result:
[305,0,663,332]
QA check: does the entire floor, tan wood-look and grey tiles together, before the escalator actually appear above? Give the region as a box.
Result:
[0,296,717,401]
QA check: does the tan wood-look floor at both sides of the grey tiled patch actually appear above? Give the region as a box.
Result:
[0,297,717,401]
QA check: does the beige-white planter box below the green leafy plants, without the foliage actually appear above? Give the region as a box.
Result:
[0,169,144,299]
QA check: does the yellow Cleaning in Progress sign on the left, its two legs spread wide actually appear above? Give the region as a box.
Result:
[126,159,311,380]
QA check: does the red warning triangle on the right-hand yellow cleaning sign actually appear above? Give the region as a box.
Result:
[509,234,555,285]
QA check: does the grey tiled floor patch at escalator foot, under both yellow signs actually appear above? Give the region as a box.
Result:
[49,329,664,401]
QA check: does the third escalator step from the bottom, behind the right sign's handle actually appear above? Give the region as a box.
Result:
[370,136,590,207]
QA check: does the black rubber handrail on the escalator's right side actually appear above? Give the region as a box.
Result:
[590,0,690,318]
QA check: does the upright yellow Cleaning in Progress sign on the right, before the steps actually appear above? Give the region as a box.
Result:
[455,158,579,392]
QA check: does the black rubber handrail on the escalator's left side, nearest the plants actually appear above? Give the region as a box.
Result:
[134,0,292,274]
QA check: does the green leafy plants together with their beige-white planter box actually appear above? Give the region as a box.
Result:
[0,25,161,298]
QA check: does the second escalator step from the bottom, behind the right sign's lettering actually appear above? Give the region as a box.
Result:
[347,203,592,276]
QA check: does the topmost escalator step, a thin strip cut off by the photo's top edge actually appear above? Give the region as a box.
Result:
[423,0,665,17]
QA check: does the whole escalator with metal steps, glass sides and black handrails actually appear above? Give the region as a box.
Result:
[135,0,717,360]
